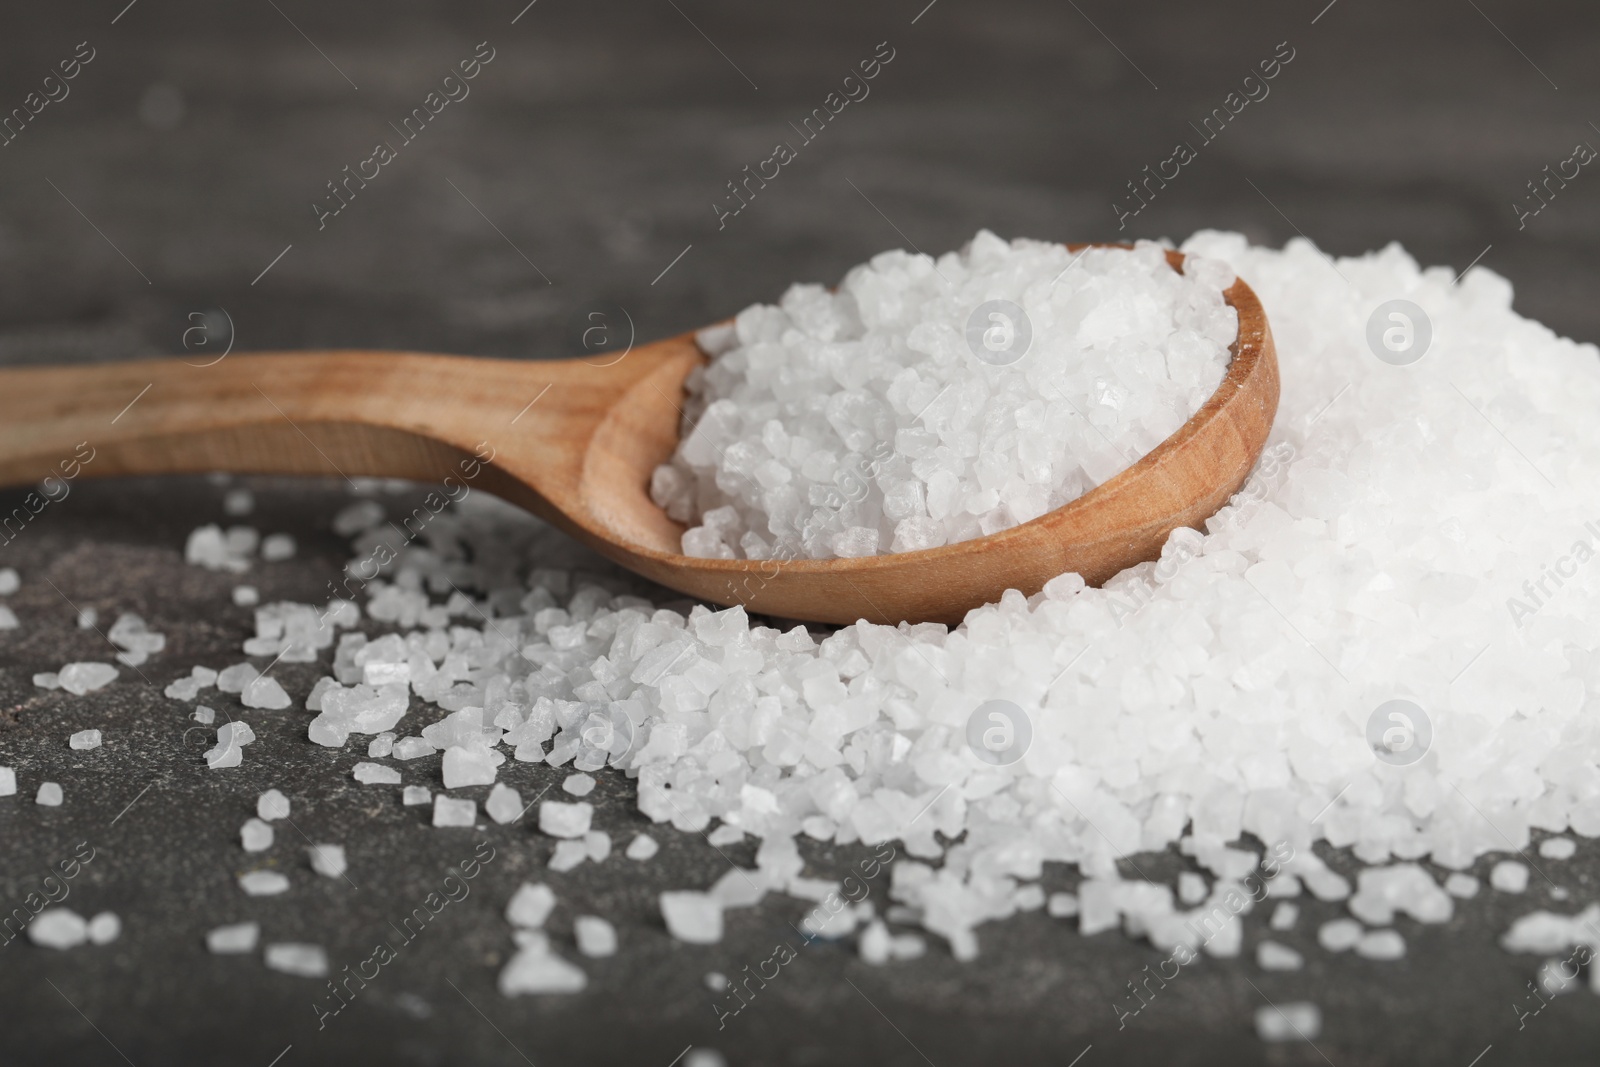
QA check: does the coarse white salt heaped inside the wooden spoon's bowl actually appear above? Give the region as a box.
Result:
[651,230,1238,560]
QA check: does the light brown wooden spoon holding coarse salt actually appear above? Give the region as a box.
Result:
[0,246,1278,624]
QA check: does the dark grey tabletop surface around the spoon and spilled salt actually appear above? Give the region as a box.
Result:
[0,0,1600,1067]
